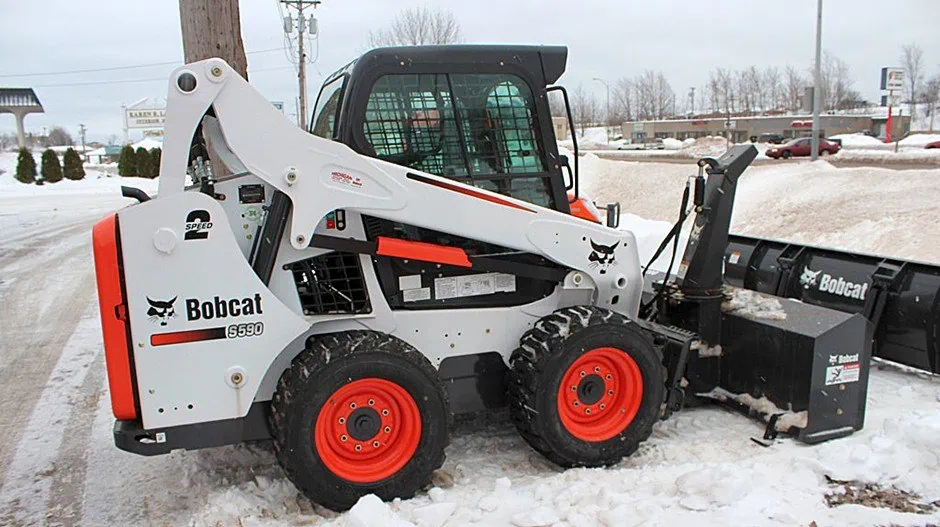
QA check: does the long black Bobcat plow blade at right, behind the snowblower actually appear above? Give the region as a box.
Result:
[724,234,940,373]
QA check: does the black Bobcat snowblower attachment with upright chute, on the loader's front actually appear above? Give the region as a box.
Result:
[645,146,872,443]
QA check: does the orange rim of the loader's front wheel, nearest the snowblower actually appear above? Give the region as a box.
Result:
[557,348,643,442]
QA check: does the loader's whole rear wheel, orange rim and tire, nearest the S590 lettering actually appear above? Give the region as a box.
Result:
[270,331,448,510]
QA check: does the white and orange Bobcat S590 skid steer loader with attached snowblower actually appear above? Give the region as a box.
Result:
[93,46,871,509]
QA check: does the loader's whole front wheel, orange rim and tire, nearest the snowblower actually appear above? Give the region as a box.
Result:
[509,306,666,467]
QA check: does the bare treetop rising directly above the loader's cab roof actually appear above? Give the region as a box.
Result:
[369,6,463,48]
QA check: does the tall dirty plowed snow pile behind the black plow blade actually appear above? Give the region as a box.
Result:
[580,154,940,262]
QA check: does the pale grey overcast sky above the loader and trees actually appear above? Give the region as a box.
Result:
[0,0,940,140]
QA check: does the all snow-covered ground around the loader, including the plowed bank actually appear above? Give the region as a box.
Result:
[0,154,940,527]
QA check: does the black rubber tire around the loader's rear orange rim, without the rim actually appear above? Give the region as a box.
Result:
[269,331,450,511]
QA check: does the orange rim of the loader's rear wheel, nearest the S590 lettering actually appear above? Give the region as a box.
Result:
[314,378,421,483]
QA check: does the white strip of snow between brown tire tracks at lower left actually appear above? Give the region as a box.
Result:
[0,303,101,526]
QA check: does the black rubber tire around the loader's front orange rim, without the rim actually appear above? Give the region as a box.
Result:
[508,306,666,467]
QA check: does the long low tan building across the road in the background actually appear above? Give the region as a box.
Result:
[622,112,911,143]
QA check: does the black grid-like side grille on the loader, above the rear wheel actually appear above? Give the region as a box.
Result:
[286,252,372,315]
